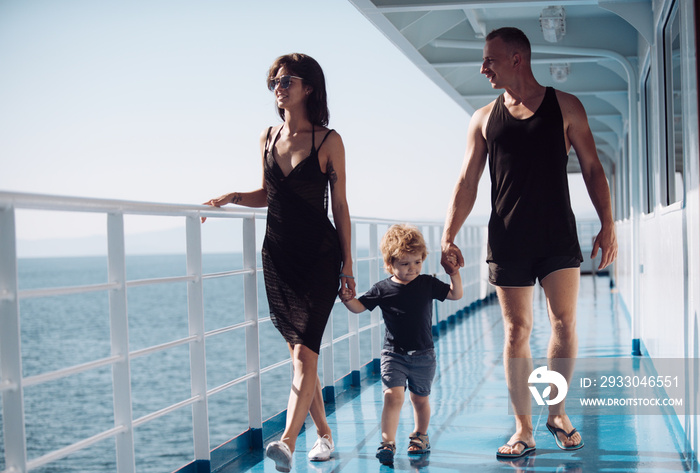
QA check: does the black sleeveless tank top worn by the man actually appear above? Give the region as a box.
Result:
[486,87,583,262]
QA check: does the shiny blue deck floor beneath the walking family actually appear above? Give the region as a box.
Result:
[224,276,698,473]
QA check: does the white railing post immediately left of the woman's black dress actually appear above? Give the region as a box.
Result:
[243,217,263,449]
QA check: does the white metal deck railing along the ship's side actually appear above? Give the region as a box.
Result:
[0,192,491,473]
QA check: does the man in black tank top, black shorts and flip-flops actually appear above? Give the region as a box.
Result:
[442,28,617,458]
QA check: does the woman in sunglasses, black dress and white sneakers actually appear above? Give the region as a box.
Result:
[206,54,355,471]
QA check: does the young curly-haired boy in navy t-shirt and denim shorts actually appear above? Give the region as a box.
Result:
[340,225,462,465]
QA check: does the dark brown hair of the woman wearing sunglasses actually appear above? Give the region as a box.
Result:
[267,53,330,126]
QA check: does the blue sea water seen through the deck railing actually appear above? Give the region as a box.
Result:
[0,254,347,473]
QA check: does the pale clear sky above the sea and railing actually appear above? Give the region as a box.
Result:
[0,0,590,243]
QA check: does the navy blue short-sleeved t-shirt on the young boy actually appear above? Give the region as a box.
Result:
[358,274,450,351]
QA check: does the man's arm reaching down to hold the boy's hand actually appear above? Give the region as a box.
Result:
[441,104,493,274]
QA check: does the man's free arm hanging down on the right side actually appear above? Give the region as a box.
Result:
[557,91,617,269]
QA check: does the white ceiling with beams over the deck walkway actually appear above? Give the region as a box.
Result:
[350,0,652,172]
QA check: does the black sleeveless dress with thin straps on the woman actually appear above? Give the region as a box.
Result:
[262,127,341,353]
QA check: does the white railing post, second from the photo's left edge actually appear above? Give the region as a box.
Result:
[107,213,136,473]
